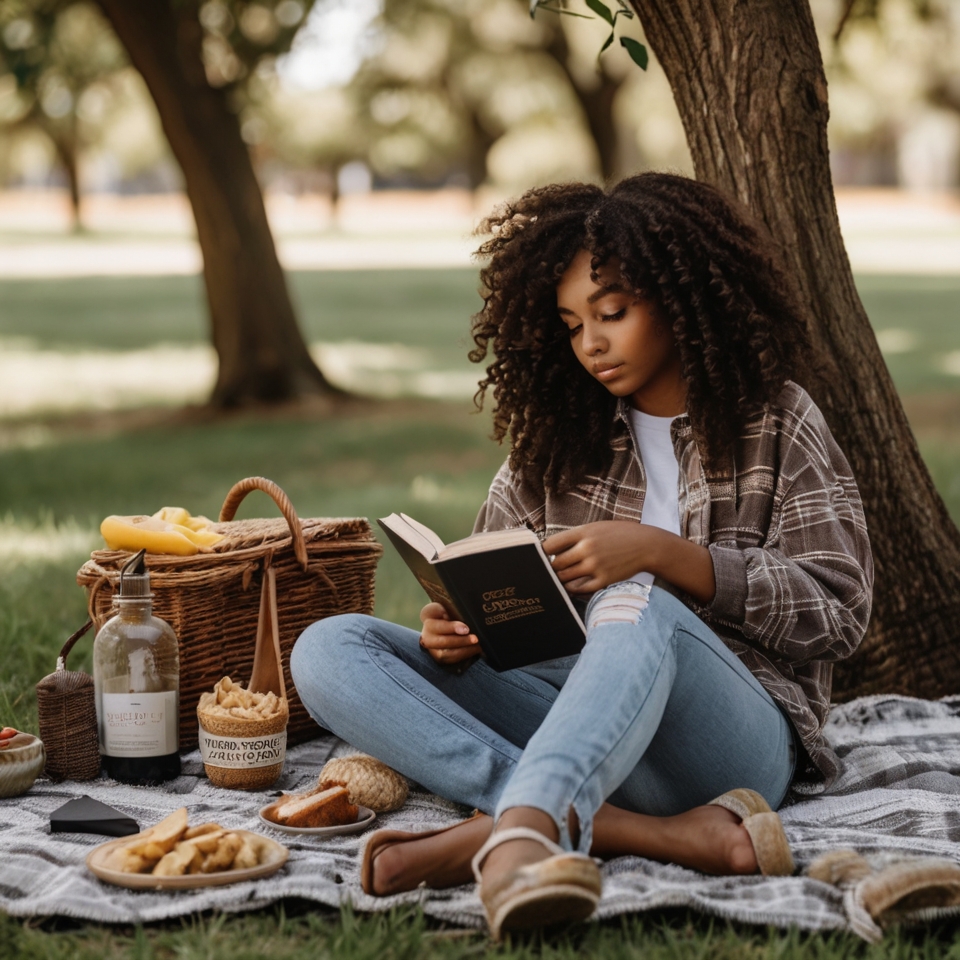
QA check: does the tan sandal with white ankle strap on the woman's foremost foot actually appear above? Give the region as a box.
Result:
[472,827,602,940]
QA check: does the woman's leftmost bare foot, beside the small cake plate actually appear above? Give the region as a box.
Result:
[372,815,493,897]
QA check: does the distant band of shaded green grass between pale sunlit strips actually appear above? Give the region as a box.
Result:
[0,269,960,393]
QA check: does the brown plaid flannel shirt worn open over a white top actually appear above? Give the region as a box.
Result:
[474,382,873,792]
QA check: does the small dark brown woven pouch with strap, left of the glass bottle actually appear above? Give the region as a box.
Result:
[37,620,100,780]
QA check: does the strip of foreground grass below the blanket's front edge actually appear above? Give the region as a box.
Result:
[0,904,960,960]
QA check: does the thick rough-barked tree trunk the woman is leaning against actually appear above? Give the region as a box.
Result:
[631,0,960,699]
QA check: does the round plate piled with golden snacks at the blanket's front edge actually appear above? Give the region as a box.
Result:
[87,807,289,890]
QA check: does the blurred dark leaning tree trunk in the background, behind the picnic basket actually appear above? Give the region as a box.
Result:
[94,0,332,406]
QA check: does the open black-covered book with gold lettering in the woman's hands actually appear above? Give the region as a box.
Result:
[378,513,586,670]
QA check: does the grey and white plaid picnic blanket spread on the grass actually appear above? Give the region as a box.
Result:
[0,696,960,940]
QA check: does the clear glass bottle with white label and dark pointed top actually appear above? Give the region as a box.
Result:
[93,550,180,784]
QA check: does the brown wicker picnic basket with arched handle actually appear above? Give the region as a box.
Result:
[77,477,383,750]
